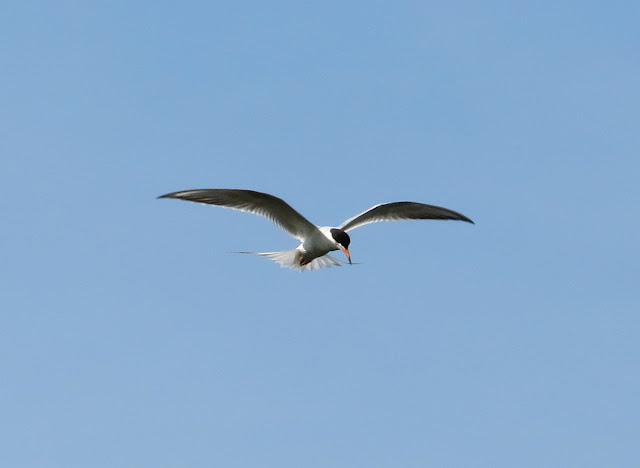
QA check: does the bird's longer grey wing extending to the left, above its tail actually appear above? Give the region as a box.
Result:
[158,189,318,241]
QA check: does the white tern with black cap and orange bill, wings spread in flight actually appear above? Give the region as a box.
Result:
[158,189,473,271]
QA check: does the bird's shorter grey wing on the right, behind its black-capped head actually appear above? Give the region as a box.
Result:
[340,202,473,231]
